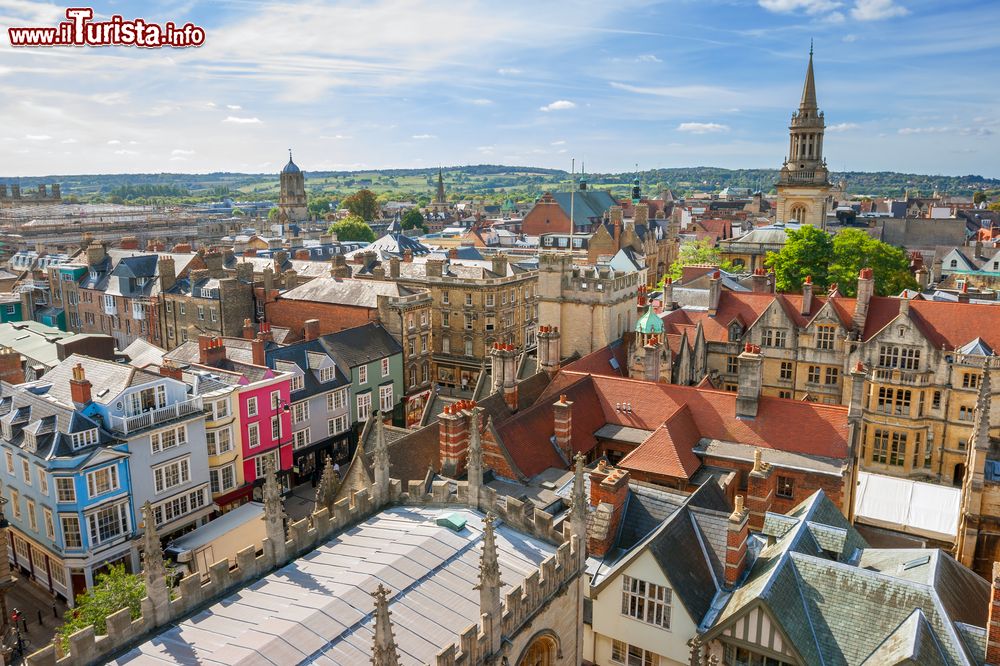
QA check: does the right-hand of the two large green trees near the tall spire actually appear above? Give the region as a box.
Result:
[829,229,917,296]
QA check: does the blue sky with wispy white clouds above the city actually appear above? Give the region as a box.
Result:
[0,0,1000,177]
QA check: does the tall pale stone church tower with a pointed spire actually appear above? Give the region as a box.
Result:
[777,44,831,229]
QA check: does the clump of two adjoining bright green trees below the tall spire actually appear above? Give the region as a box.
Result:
[766,226,917,296]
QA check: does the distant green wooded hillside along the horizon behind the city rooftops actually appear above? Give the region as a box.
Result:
[0,164,1000,203]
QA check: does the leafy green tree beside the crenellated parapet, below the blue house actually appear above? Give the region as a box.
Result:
[56,564,147,647]
